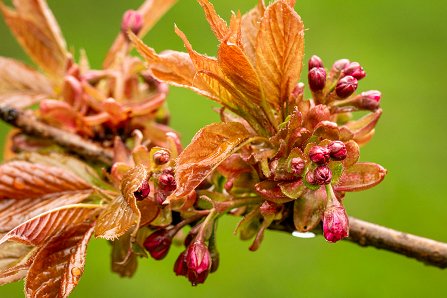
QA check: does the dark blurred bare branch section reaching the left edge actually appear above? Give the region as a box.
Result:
[0,105,113,165]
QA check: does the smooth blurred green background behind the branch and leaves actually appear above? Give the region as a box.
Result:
[0,0,447,298]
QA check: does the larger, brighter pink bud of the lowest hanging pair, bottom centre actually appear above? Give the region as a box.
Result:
[185,241,211,286]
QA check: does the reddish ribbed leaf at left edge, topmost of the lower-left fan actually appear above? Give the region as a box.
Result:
[0,161,91,199]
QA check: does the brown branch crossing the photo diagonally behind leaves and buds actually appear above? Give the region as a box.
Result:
[0,106,447,268]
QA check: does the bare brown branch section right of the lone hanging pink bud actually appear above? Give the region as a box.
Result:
[347,217,447,269]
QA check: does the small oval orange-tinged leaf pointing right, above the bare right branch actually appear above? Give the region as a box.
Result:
[334,162,387,191]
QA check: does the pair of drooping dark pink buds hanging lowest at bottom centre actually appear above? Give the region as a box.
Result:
[174,240,214,286]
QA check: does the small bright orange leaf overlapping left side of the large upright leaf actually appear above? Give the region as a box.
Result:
[217,42,263,103]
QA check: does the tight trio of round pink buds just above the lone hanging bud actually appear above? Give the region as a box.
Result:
[306,141,347,185]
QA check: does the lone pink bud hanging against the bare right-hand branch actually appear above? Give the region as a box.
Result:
[323,203,349,243]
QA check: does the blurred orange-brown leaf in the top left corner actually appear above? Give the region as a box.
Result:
[0,0,67,81]
